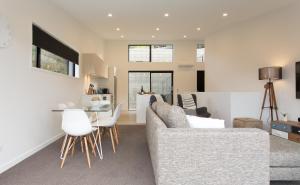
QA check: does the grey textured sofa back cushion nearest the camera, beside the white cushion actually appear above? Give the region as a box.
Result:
[156,102,189,128]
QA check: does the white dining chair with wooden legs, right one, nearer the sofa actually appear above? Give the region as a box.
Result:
[92,104,122,153]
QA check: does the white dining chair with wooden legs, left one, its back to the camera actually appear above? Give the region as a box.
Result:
[61,109,102,168]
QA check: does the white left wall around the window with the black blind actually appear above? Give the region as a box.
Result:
[0,0,103,173]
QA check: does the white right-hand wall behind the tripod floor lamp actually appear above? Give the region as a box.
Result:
[205,3,300,123]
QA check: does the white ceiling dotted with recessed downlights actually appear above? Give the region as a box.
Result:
[50,0,297,40]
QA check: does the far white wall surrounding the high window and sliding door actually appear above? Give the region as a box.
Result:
[105,40,204,110]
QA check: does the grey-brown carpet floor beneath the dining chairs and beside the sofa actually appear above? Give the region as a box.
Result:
[0,126,300,185]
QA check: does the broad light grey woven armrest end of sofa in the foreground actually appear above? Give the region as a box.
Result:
[155,128,270,185]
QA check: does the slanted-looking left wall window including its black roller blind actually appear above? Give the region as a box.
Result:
[32,25,79,78]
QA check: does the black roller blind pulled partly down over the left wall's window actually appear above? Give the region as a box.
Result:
[32,25,79,64]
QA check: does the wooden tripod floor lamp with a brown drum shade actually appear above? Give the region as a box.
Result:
[258,67,282,121]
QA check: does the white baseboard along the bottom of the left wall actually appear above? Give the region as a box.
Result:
[0,133,64,174]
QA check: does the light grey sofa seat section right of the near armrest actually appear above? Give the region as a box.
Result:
[270,135,300,167]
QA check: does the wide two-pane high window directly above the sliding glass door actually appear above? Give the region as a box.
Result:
[128,44,173,62]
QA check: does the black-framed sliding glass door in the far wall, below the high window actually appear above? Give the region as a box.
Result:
[128,71,173,110]
